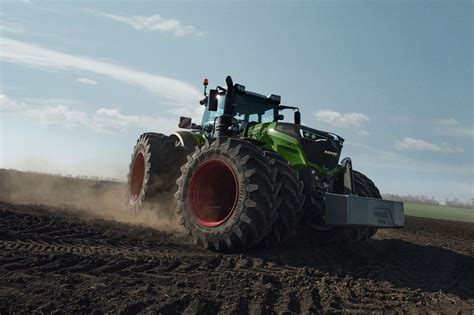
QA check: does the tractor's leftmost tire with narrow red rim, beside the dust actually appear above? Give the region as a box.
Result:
[126,133,186,213]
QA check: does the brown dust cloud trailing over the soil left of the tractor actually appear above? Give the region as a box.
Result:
[0,169,183,234]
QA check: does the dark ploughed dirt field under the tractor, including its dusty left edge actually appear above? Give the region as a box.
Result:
[0,170,474,314]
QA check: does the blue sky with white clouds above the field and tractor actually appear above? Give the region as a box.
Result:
[0,0,474,201]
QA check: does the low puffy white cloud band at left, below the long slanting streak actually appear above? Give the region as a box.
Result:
[0,93,177,134]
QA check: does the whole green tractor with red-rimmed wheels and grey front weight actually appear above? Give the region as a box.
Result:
[127,76,405,251]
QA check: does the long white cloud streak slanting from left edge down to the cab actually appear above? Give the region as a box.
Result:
[0,38,202,118]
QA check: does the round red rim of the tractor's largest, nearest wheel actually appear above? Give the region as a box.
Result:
[189,160,238,227]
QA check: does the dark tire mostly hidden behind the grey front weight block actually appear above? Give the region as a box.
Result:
[299,171,382,245]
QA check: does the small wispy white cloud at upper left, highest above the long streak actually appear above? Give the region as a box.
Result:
[96,12,203,37]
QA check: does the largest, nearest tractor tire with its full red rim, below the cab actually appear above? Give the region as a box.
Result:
[175,138,280,251]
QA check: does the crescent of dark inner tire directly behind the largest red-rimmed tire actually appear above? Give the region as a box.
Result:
[263,151,305,247]
